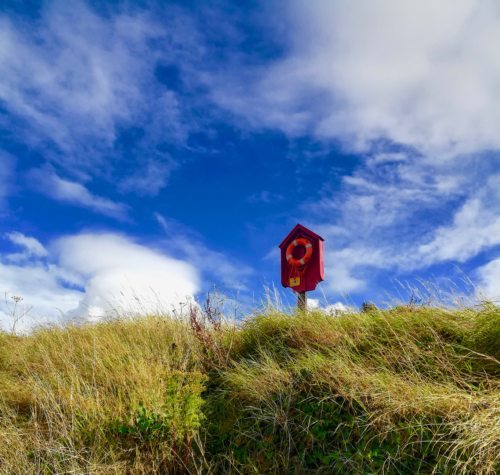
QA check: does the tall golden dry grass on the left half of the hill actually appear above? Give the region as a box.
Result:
[0,318,205,474]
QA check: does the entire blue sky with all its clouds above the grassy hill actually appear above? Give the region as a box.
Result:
[0,0,500,328]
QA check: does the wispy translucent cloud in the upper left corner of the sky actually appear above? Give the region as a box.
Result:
[0,2,148,158]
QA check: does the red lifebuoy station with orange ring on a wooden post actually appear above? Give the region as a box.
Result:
[279,224,325,309]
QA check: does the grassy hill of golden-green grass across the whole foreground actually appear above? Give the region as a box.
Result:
[0,305,500,474]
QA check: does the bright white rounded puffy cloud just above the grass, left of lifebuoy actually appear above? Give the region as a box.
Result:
[53,233,199,324]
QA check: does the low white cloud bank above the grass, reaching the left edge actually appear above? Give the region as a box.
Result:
[0,233,200,329]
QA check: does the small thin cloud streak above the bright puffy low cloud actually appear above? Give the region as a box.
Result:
[28,169,128,220]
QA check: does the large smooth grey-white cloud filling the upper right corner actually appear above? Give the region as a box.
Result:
[292,0,500,155]
